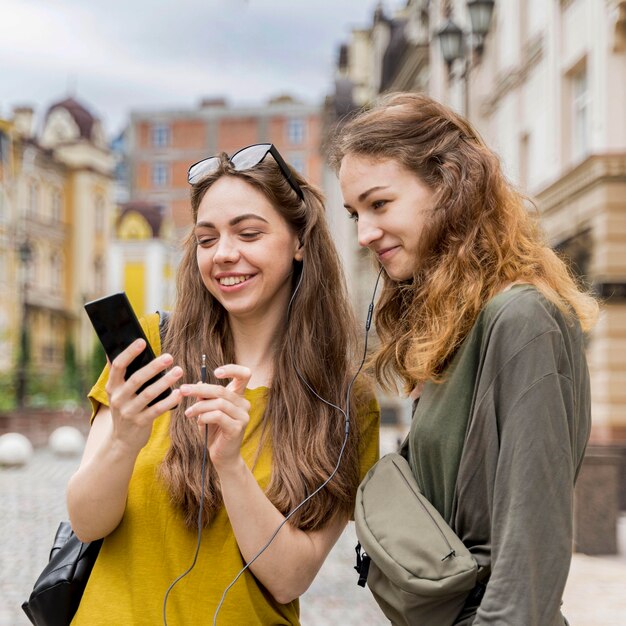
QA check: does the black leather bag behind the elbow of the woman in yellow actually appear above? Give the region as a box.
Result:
[22,522,102,626]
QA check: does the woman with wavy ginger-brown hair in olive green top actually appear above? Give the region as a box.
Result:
[333,94,597,626]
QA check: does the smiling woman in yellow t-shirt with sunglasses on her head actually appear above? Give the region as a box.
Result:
[68,144,378,626]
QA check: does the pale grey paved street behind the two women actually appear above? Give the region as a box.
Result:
[0,442,626,626]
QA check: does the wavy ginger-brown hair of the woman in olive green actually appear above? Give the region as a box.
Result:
[331,93,598,391]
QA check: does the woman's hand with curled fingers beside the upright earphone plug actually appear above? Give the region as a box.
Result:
[180,365,252,472]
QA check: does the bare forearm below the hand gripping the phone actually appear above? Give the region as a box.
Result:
[67,437,137,541]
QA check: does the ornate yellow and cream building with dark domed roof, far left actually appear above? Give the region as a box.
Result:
[0,98,113,390]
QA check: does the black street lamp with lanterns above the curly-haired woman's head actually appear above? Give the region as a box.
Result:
[437,0,496,118]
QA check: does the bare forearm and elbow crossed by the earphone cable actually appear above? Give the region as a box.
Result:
[220,460,343,604]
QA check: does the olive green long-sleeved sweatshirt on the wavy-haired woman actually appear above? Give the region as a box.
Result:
[409,285,591,626]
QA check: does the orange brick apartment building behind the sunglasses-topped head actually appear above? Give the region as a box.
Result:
[127,97,322,235]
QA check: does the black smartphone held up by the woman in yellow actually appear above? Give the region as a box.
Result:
[85,291,172,406]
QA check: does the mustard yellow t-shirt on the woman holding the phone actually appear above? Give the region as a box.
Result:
[72,315,379,626]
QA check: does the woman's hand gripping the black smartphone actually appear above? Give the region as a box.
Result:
[106,339,183,453]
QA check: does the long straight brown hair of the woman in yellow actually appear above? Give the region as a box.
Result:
[161,154,364,530]
